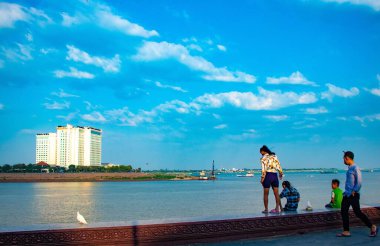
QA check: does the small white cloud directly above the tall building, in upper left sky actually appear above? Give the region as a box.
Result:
[66,45,121,73]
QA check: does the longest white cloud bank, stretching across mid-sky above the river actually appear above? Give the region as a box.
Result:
[104,88,317,127]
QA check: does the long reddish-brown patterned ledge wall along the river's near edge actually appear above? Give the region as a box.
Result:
[0,207,380,245]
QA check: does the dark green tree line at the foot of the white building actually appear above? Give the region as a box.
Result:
[0,163,141,173]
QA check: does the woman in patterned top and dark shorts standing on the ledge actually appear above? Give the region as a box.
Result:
[260,145,283,214]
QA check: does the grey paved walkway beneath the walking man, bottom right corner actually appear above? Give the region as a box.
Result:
[197,227,380,246]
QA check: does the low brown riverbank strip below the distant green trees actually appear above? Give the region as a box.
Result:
[0,173,197,183]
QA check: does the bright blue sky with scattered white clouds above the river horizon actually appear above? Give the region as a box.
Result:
[0,0,380,169]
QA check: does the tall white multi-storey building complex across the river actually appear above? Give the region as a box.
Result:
[36,124,102,167]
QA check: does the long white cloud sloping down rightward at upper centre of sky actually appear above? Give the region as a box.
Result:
[134,41,256,83]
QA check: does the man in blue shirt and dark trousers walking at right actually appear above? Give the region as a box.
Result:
[336,151,378,237]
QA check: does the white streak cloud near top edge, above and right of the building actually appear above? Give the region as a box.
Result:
[95,5,159,38]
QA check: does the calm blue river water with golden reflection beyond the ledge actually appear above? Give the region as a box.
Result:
[0,172,380,231]
